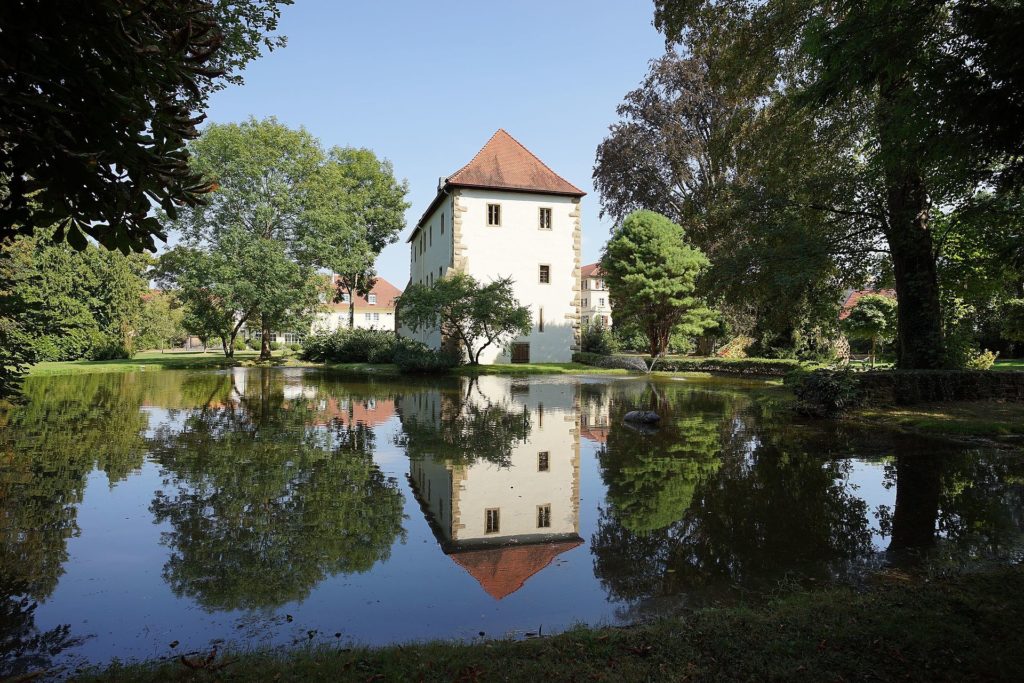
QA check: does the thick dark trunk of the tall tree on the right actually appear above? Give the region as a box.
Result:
[878,88,945,370]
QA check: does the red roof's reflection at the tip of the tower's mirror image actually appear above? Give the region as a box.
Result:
[452,539,583,600]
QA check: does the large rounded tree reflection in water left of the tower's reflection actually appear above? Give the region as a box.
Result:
[151,372,402,609]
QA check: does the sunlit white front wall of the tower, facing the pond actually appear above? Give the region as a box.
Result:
[456,189,579,364]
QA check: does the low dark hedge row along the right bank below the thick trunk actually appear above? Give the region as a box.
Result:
[786,370,1024,417]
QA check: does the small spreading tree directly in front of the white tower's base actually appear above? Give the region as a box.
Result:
[396,273,531,366]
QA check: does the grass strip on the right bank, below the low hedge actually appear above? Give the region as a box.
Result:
[854,400,1024,437]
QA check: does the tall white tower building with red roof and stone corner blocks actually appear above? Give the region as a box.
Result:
[399,130,585,365]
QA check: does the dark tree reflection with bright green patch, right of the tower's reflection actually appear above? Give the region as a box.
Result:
[592,388,870,600]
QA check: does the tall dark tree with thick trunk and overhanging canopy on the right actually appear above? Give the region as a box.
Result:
[654,0,1024,368]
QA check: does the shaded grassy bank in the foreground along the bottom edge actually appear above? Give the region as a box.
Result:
[80,567,1024,681]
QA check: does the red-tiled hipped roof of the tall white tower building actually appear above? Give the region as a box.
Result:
[407,128,587,237]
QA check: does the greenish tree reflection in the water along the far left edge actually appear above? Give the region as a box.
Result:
[0,375,147,676]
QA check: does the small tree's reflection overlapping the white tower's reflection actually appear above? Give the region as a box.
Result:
[396,379,530,467]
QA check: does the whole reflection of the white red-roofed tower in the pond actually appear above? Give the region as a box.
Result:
[399,377,583,600]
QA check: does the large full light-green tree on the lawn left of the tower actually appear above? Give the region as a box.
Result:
[165,118,382,360]
